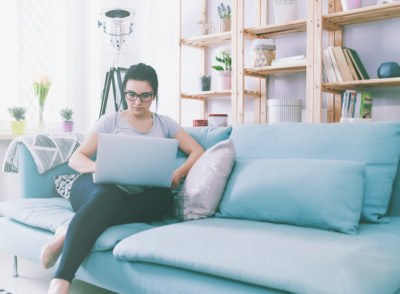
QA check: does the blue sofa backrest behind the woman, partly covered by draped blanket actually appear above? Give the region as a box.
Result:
[19,127,232,198]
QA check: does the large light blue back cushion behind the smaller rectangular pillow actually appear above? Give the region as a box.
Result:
[231,122,400,222]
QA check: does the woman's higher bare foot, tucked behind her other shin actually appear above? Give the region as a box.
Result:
[40,225,68,269]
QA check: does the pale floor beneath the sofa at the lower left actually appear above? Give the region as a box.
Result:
[0,251,114,294]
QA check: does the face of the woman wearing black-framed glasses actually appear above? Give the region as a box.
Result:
[125,80,154,116]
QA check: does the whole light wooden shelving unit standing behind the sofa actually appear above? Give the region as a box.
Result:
[180,0,400,124]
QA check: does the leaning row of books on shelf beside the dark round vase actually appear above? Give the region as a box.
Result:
[322,46,369,83]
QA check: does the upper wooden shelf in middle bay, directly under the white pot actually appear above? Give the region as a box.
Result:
[244,19,307,38]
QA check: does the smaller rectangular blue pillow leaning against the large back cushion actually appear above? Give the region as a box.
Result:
[218,159,365,234]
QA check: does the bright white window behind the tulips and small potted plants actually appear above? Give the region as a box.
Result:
[0,0,67,122]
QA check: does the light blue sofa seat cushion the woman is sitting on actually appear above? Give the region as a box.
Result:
[0,198,178,251]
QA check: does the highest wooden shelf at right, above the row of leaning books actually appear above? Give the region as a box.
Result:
[322,2,400,30]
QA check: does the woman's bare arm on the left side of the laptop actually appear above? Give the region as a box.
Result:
[68,133,99,173]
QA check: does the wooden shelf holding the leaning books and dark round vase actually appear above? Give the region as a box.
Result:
[322,78,400,93]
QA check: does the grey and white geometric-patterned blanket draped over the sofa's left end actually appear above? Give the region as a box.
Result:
[2,133,86,174]
